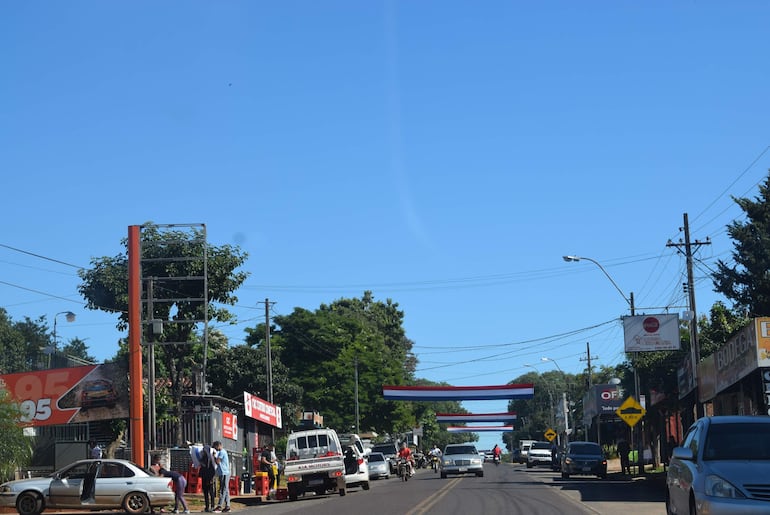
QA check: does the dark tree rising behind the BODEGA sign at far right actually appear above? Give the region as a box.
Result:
[713,176,770,317]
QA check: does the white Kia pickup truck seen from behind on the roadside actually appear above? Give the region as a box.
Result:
[283,429,345,501]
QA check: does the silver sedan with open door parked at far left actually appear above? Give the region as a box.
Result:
[0,459,174,515]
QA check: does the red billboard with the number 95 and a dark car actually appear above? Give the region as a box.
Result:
[0,363,128,426]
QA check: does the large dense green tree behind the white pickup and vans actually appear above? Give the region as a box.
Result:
[271,291,416,434]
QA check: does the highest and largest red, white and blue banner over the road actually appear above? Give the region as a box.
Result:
[382,383,535,401]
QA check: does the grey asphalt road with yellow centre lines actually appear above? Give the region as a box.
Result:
[230,464,665,515]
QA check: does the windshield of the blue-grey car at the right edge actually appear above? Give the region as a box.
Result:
[703,423,770,460]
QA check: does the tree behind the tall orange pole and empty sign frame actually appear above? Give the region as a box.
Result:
[78,224,248,445]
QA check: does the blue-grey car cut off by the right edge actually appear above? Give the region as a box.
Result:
[666,416,770,515]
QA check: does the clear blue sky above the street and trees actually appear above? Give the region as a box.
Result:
[0,0,770,447]
